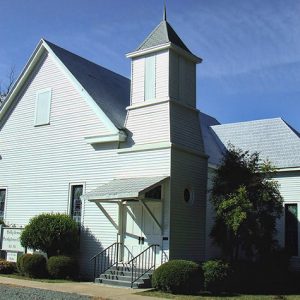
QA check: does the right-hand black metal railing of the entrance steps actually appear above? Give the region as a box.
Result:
[128,245,159,288]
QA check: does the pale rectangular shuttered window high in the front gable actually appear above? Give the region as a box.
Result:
[34,89,51,126]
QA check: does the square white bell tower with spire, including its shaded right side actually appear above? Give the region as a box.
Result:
[125,5,207,261]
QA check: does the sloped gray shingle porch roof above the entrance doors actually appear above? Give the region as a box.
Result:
[83,176,169,202]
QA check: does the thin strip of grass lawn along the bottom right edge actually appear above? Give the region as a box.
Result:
[138,291,300,300]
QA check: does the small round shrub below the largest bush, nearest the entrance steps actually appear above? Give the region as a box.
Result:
[47,255,78,279]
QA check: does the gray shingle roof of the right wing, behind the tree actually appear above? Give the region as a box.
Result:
[208,118,300,168]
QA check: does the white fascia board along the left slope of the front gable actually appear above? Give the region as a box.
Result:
[0,40,45,120]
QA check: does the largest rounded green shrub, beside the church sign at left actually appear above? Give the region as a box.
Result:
[20,214,79,257]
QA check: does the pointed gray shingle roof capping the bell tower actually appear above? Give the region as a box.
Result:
[136,20,191,53]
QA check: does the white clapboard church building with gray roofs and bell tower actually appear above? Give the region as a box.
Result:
[0,9,300,286]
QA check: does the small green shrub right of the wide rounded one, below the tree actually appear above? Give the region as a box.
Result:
[202,260,230,293]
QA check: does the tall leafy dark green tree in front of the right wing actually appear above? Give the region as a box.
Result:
[211,145,283,261]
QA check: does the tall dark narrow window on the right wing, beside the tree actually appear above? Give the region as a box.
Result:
[285,204,298,256]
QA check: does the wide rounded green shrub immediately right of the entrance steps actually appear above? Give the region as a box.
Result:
[152,260,203,294]
